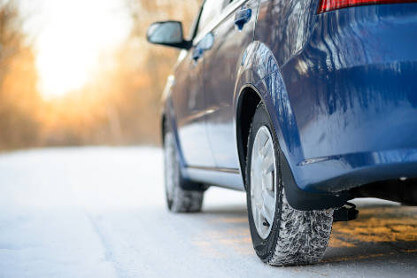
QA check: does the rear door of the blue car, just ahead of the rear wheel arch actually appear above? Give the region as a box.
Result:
[203,0,259,170]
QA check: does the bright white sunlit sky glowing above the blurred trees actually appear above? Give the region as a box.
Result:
[22,0,131,98]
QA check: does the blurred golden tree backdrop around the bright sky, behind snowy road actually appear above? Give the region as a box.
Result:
[0,0,200,149]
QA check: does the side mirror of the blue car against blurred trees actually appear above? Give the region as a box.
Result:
[146,21,191,49]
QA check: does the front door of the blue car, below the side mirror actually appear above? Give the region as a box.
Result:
[172,5,215,167]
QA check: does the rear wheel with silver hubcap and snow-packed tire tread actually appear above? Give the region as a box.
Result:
[246,103,333,266]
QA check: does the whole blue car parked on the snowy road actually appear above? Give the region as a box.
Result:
[147,0,417,265]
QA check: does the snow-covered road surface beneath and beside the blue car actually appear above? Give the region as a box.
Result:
[0,147,417,277]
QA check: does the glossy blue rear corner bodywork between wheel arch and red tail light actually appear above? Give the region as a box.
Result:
[255,1,417,192]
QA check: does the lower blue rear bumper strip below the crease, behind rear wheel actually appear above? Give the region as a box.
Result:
[298,149,417,192]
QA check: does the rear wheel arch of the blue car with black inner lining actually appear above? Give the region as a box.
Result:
[234,41,349,207]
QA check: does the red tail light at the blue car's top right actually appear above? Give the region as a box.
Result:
[317,0,417,13]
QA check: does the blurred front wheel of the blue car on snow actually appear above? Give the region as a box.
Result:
[164,122,204,213]
